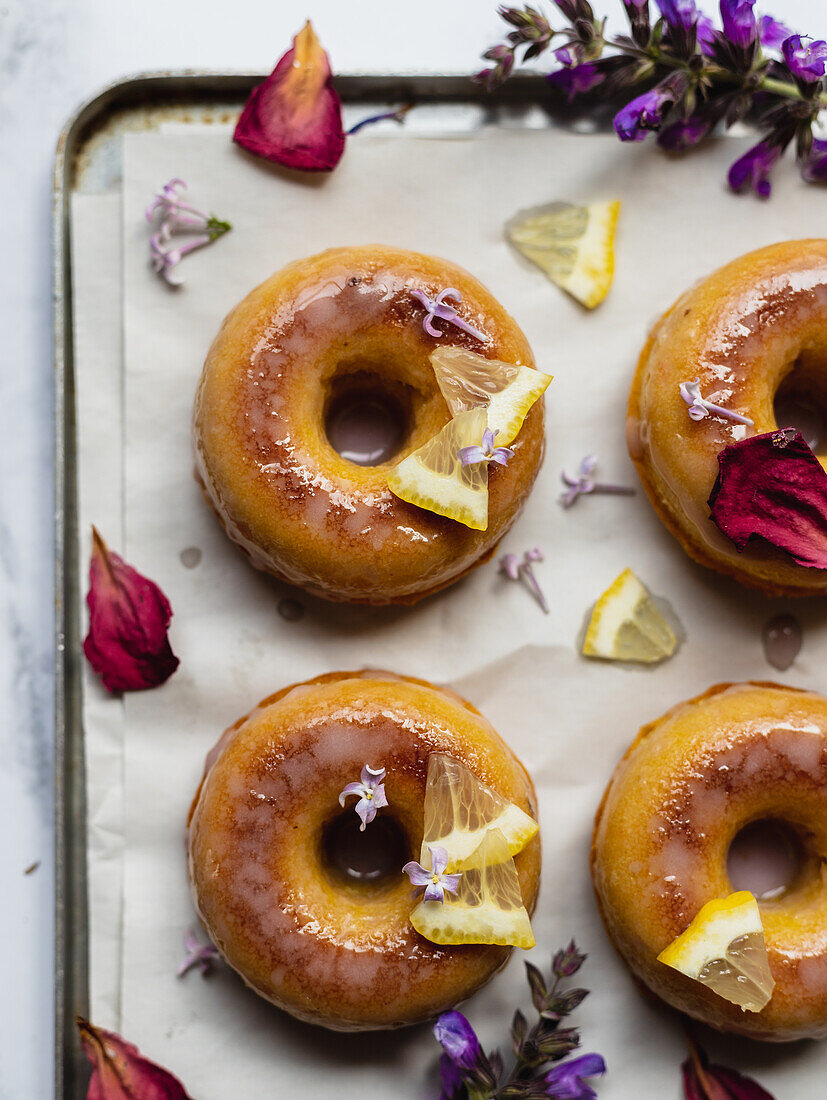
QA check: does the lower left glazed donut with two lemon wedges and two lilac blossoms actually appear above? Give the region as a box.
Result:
[188,672,540,1031]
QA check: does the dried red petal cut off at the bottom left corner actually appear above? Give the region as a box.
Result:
[77,1016,191,1100]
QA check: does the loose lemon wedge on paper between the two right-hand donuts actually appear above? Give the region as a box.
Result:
[583,569,677,664]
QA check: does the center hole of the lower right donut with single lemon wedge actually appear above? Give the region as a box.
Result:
[727,817,807,901]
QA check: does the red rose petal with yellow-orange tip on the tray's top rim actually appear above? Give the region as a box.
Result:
[233,20,344,172]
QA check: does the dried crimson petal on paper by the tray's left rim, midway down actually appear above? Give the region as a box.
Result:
[84,528,178,692]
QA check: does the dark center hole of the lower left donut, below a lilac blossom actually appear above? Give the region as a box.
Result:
[321,809,412,889]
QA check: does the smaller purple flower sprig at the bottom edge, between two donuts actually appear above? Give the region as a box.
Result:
[433,941,606,1100]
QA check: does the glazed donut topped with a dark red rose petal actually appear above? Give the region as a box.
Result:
[627,240,827,596]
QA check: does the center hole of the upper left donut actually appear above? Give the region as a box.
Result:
[324,367,416,466]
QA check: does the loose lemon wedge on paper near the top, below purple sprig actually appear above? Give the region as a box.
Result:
[506,200,620,309]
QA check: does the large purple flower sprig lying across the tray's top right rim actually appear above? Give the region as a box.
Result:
[474,0,827,198]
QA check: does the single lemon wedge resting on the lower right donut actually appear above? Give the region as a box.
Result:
[658,890,775,1012]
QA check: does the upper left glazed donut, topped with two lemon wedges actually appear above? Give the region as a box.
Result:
[194,245,543,604]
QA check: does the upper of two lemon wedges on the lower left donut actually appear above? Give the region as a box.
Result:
[419,752,540,871]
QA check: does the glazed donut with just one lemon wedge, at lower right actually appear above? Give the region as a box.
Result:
[592,683,827,1042]
